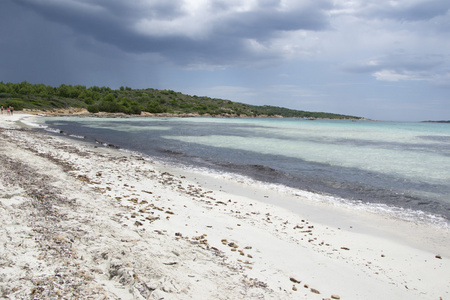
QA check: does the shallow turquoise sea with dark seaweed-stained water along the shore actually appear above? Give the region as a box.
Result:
[34,117,450,227]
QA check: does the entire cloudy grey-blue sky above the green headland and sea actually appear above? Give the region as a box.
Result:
[0,0,450,121]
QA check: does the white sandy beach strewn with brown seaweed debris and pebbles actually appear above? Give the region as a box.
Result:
[0,113,450,299]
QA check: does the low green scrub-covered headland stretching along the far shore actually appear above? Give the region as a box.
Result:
[0,81,360,119]
